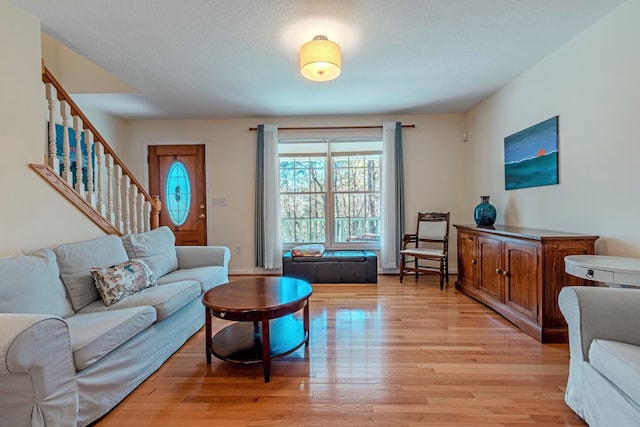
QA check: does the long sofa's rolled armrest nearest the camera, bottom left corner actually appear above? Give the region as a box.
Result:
[0,313,78,426]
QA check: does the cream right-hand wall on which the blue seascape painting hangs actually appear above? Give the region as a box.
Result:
[466,0,640,256]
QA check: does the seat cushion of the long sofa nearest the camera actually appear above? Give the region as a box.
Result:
[66,308,156,371]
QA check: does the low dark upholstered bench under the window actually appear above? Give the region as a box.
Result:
[282,250,378,283]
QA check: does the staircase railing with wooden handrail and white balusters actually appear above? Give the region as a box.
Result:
[29,64,161,235]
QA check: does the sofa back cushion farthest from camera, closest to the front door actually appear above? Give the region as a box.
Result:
[122,226,178,279]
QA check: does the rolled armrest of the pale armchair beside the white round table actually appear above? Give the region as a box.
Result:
[558,286,640,360]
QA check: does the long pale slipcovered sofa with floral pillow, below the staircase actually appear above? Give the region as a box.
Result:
[0,227,230,427]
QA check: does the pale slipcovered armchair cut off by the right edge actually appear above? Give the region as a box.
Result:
[559,286,640,427]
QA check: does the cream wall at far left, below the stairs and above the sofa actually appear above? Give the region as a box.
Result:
[0,0,104,256]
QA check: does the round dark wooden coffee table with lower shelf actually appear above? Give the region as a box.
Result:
[202,277,313,382]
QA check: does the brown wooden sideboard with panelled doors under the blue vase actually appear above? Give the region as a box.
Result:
[454,225,598,342]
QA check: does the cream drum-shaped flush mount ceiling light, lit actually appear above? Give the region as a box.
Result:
[300,36,342,82]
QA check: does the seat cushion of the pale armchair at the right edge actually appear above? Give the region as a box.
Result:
[589,339,640,402]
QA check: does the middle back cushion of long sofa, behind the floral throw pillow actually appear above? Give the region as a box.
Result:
[55,235,129,311]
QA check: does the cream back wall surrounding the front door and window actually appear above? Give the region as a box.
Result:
[124,114,466,273]
